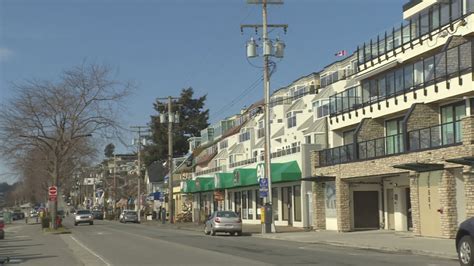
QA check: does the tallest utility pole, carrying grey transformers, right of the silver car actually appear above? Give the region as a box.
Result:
[240,0,288,233]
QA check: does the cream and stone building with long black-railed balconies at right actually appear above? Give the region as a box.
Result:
[312,0,474,238]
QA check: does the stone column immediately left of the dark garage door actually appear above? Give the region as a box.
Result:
[336,177,351,232]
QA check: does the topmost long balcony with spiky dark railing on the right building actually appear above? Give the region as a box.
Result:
[357,0,466,65]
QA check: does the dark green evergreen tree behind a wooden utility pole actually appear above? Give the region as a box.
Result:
[145,88,209,165]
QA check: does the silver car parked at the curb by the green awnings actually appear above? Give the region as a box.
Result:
[204,211,242,236]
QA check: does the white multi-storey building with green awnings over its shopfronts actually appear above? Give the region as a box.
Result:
[182,73,334,227]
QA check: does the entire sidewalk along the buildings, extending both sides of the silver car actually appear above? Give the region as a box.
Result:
[142,221,457,259]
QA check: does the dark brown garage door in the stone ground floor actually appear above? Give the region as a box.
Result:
[354,191,379,229]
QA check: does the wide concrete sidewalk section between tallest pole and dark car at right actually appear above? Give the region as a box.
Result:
[258,230,457,259]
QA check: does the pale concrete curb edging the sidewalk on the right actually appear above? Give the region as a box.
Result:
[255,235,458,260]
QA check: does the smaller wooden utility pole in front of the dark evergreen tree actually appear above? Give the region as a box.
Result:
[158,96,179,224]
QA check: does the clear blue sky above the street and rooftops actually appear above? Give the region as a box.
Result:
[0,0,407,182]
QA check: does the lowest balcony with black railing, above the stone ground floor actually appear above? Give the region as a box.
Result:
[318,120,462,167]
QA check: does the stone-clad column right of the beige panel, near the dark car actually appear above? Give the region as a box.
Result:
[439,169,457,238]
